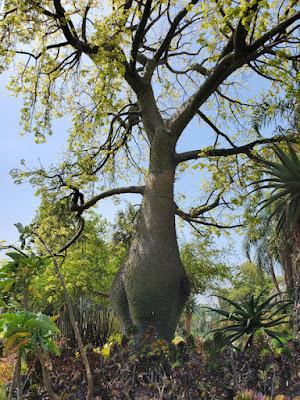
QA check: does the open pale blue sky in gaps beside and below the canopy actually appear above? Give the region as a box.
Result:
[0,67,243,261]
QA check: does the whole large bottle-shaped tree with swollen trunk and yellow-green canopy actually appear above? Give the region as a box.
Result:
[0,0,300,339]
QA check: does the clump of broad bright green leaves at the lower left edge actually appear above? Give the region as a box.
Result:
[0,311,59,354]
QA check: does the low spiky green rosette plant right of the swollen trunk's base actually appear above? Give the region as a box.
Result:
[206,291,291,350]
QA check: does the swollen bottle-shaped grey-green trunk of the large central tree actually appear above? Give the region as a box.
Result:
[111,132,190,339]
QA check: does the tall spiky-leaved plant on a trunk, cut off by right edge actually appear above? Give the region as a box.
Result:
[254,143,300,337]
